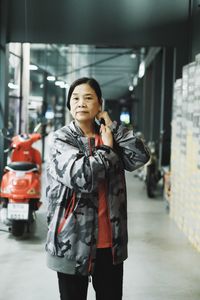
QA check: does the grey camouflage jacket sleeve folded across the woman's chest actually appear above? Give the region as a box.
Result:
[47,134,119,193]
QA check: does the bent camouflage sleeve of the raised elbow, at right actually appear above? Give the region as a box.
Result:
[113,125,150,171]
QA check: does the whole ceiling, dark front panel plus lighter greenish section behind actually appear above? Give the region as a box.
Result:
[4,0,192,99]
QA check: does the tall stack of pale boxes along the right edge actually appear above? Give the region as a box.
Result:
[170,55,200,251]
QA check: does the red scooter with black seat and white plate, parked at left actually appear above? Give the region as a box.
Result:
[0,124,42,236]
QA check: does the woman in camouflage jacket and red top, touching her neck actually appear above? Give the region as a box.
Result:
[46,77,149,300]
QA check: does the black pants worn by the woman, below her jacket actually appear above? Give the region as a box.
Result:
[58,249,123,300]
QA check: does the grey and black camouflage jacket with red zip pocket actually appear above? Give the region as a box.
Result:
[46,121,149,275]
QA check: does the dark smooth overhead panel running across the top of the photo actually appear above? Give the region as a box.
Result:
[7,0,192,47]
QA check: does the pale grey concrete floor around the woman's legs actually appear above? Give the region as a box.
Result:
[0,169,200,300]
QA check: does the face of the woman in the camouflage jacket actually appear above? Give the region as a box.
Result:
[70,83,101,122]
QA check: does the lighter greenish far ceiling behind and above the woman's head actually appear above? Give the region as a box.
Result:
[31,44,144,99]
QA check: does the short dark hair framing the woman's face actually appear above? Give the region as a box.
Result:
[67,77,102,110]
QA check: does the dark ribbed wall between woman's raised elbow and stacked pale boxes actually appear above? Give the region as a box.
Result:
[131,47,175,165]
